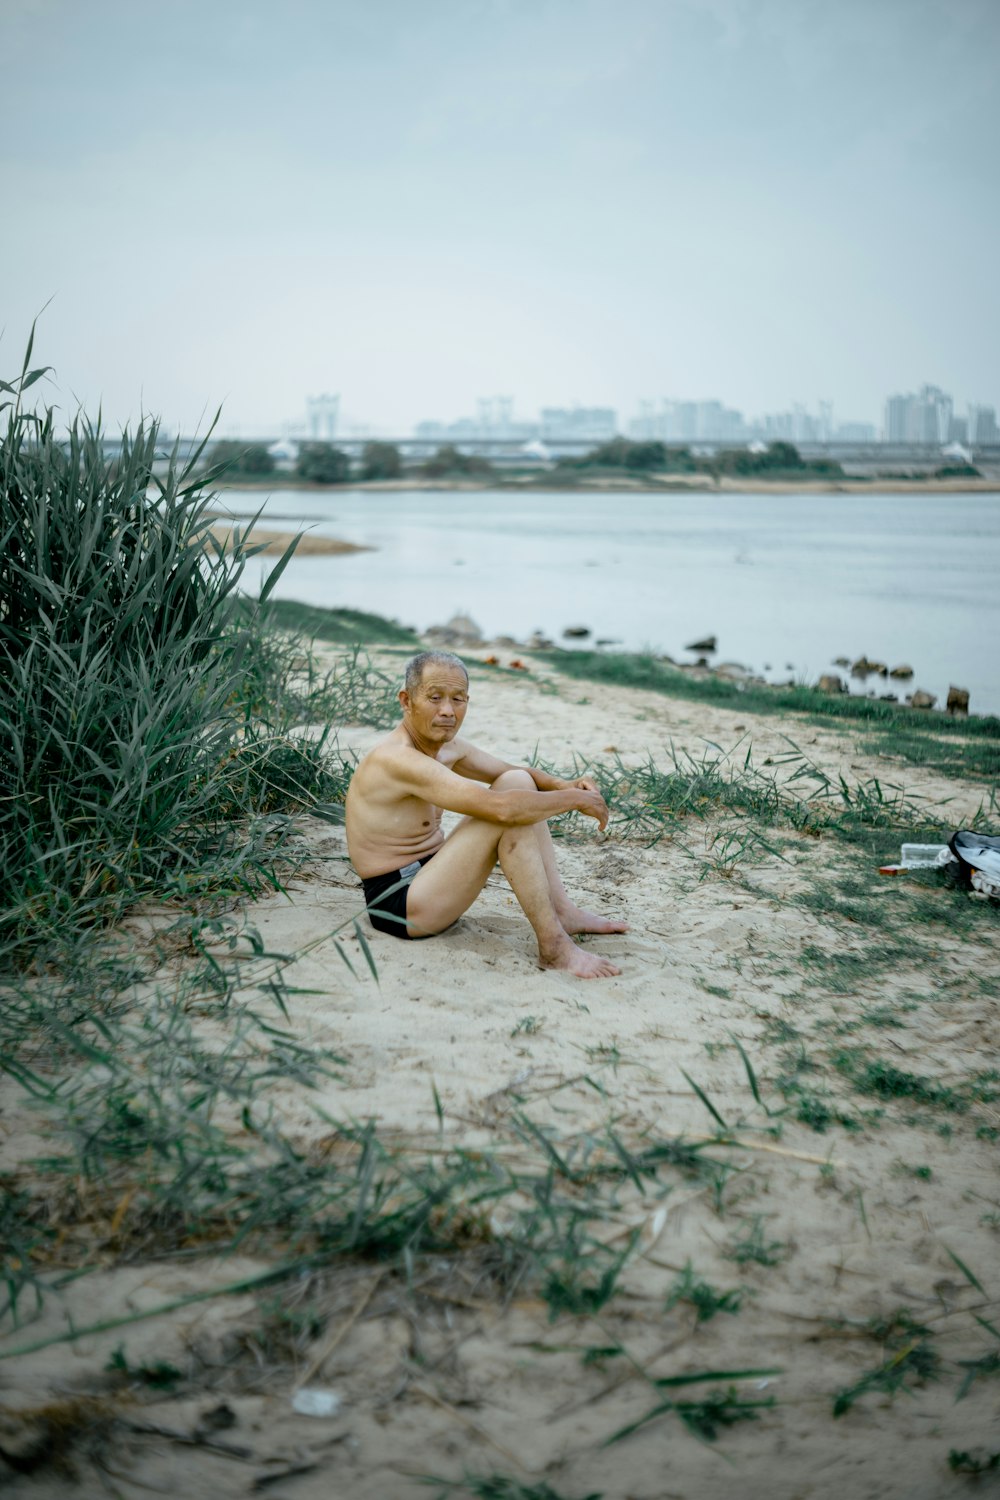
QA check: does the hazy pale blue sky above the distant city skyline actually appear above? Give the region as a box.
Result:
[0,0,1000,434]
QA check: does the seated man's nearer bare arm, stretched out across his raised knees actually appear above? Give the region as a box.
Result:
[391,750,609,828]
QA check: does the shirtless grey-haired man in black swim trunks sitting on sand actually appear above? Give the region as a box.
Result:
[346,651,628,980]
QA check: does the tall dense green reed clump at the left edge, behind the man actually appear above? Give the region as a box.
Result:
[0,344,319,962]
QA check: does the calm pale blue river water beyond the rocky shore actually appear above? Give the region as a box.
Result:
[219,489,1000,713]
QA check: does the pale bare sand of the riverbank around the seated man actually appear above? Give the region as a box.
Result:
[0,653,1000,1500]
